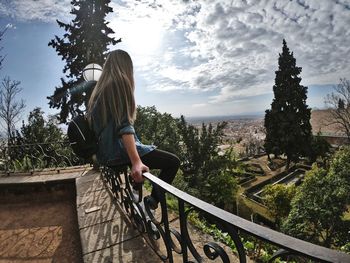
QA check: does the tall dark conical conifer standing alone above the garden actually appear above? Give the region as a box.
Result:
[264,40,312,167]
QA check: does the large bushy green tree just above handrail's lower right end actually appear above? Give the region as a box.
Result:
[283,168,342,247]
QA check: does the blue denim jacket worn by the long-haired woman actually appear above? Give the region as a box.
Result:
[92,105,156,165]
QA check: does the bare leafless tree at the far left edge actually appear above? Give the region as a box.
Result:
[0,76,25,145]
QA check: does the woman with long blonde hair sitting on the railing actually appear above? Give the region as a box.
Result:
[87,50,180,209]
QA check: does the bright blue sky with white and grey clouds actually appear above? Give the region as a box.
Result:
[0,0,350,116]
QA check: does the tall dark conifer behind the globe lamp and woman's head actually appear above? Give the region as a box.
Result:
[47,0,121,123]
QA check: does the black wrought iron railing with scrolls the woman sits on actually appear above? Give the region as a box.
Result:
[102,167,350,263]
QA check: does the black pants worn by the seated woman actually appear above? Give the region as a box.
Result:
[141,149,180,202]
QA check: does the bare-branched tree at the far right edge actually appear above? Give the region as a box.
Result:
[325,79,350,142]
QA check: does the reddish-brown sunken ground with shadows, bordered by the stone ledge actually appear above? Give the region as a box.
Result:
[0,183,82,263]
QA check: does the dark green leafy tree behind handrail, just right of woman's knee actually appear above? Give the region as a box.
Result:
[179,116,238,211]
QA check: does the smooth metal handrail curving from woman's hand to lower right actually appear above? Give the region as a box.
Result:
[143,173,350,263]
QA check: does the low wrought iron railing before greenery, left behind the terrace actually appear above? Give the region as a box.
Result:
[0,141,84,173]
